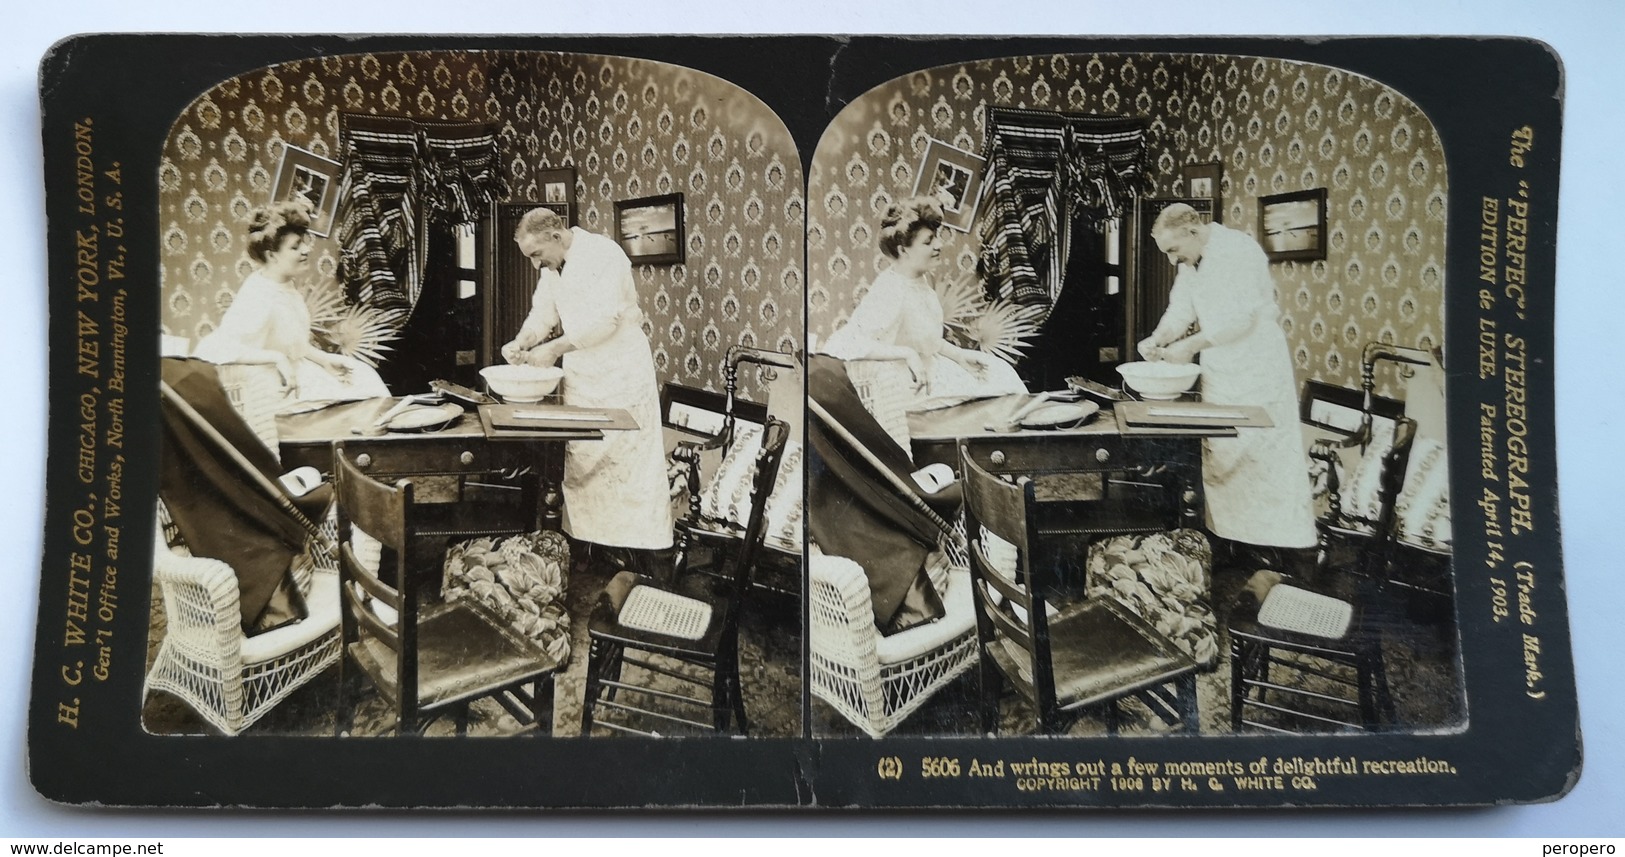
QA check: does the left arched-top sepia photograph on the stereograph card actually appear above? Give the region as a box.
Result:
[140,50,803,738]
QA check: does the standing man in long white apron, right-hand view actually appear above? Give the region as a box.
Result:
[1139,203,1315,561]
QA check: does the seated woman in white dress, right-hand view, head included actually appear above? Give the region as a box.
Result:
[822,197,1027,410]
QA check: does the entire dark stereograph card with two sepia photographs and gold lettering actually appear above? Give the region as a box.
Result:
[28,34,1580,810]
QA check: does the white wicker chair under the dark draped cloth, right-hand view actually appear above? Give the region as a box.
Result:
[808,555,977,738]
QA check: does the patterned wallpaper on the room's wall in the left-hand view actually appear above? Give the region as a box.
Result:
[159,50,804,395]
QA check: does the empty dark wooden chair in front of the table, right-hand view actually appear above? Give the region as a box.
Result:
[960,446,1198,733]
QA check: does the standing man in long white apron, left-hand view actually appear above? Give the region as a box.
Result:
[502,208,673,572]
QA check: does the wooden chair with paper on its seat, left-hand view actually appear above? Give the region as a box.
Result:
[582,418,790,737]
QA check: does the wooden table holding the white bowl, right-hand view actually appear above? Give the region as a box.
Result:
[908,395,1237,533]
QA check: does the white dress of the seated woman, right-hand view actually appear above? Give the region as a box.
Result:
[822,268,1027,410]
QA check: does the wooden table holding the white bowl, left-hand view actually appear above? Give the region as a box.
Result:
[276,398,631,535]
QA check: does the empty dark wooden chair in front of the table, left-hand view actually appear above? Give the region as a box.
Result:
[335,449,561,735]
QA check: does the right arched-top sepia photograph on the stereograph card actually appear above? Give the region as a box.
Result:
[808,54,1469,738]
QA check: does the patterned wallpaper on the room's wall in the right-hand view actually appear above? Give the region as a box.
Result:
[808,54,1448,392]
